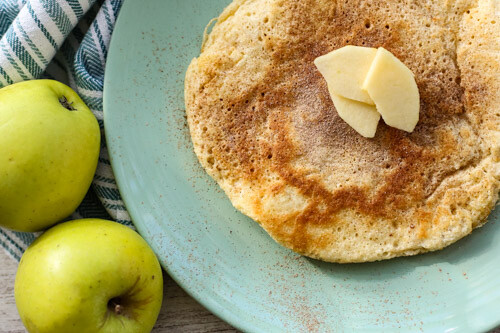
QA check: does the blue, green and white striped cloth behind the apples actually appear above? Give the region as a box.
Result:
[0,0,131,260]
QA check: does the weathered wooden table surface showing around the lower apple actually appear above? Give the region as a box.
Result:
[0,249,500,333]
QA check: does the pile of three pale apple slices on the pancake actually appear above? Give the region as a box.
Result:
[314,45,420,138]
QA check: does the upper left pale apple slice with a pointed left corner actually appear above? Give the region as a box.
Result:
[314,45,377,105]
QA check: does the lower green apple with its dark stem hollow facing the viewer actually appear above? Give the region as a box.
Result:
[14,219,163,333]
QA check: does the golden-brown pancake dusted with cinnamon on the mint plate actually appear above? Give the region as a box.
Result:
[185,0,500,262]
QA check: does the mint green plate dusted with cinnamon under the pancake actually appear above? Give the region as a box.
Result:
[104,0,500,332]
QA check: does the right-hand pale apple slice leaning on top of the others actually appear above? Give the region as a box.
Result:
[362,47,420,132]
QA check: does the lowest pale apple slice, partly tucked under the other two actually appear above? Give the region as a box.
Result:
[328,88,380,138]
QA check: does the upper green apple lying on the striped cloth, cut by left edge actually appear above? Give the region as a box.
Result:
[0,80,101,231]
